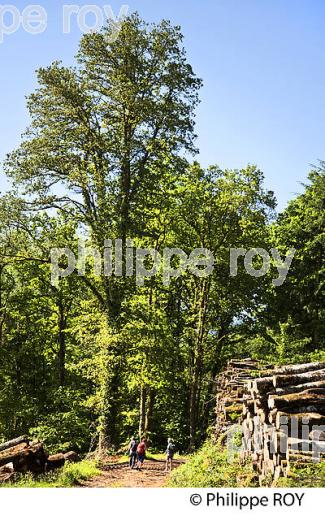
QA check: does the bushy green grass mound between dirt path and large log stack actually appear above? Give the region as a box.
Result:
[167,441,258,487]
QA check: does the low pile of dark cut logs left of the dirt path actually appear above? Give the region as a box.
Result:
[0,435,78,483]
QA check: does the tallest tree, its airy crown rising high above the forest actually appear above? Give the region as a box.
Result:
[7,14,201,447]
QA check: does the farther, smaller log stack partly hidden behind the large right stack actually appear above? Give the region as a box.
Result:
[215,358,272,438]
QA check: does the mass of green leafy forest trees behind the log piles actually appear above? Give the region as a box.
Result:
[0,14,325,460]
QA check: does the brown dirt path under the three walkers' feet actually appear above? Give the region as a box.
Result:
[82,460,183,488]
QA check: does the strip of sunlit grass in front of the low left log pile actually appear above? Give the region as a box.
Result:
[1,460,100,488]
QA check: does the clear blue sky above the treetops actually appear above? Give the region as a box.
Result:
[0,0,325,209]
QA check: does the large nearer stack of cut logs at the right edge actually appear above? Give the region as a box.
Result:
[242,363,325,483]
